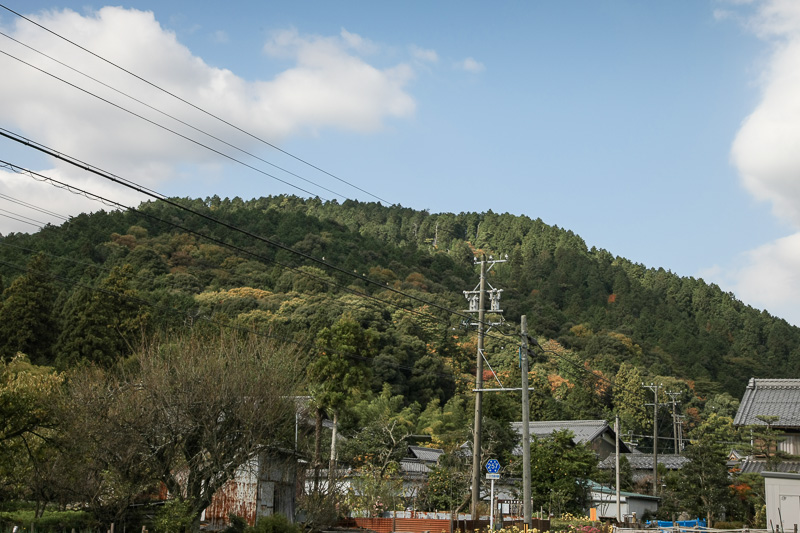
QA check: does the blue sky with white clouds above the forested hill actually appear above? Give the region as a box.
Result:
[0,0,800,326]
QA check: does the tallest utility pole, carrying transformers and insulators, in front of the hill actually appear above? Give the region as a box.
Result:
[464,255,505,520]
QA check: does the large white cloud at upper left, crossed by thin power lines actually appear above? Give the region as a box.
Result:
[0,7,415,232]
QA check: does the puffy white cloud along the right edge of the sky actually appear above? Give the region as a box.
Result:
[727,0,800,325]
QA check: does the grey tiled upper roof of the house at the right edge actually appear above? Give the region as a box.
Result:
[733,378,800,428]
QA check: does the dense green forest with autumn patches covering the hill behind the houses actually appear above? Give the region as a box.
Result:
[0,196,800,524]
